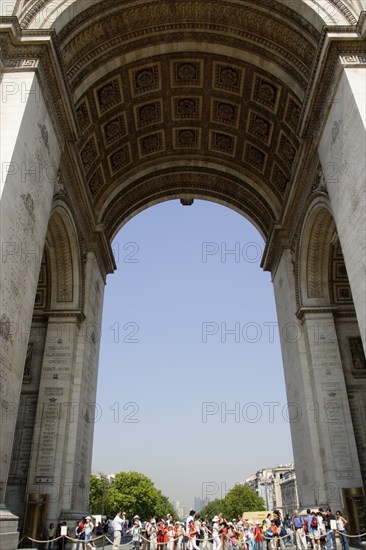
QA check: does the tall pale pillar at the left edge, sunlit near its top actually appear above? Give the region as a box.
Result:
[0,71,60,550]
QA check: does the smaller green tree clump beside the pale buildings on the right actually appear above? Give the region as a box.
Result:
[200,483,265,520]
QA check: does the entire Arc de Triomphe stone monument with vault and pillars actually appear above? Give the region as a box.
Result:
[0,0,366,550]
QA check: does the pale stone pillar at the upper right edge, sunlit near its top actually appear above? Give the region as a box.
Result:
[318,61,366,350]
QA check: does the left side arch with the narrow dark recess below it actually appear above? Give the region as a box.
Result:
[7,205,81,530]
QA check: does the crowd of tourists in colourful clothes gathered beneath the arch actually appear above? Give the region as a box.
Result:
[111,508,349,550]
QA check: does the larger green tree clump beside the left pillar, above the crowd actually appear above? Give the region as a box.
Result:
[89,472,174,519]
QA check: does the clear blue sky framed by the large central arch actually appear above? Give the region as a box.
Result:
[93,200,293,505]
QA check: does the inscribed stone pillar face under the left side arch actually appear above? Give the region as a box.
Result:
[27,311,80,524]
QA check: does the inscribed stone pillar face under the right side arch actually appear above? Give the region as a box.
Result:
[302,309,362,502]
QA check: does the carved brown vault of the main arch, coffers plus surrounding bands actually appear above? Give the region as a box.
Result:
[53,0,320,236]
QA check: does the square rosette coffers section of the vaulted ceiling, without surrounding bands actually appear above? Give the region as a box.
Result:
[76,54,301,224]
